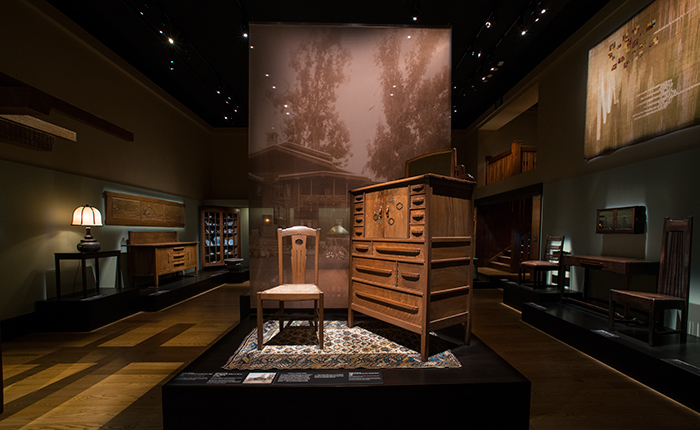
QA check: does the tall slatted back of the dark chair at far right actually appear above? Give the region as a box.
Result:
[657,217,693,299]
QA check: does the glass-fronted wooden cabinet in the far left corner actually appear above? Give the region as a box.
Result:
[201,207,241,267]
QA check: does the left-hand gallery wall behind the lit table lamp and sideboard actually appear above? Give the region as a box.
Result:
[0,0,247,326]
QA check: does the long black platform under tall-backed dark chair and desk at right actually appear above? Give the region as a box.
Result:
[522,303,700,412]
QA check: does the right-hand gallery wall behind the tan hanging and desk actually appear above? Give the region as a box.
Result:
[465,0,700,335]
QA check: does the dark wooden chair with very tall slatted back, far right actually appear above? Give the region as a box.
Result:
[608,216,693,346]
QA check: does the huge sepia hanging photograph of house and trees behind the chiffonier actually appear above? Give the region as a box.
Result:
[248,24,451,308]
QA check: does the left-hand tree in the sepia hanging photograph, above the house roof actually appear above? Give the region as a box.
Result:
[267,29,351,166]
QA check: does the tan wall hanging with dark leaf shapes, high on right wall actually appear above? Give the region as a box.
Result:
[585,0,700,159]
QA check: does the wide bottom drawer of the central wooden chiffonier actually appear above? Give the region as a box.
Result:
[352,281,423,326]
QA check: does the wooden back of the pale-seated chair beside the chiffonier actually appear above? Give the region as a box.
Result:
[277,226,320,285]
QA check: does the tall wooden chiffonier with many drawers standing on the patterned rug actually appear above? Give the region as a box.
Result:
[348,174,475,361]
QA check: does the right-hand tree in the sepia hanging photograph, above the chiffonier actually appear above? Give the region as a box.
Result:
[364,29,450,180]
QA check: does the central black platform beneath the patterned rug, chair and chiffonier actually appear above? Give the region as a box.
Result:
[162,316,530,430]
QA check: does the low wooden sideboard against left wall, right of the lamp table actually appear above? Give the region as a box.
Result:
[127,231,199,287]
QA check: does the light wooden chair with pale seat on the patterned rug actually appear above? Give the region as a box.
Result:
[257,226,323,349]
